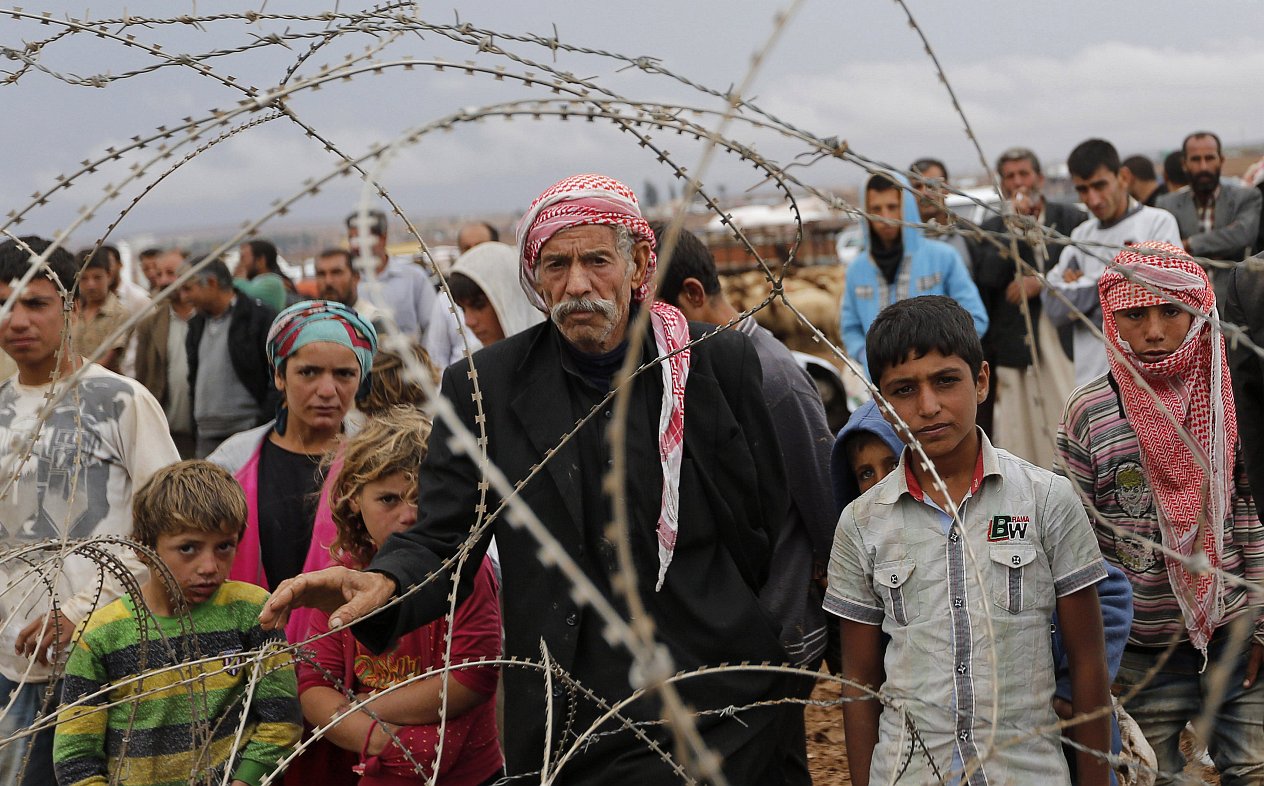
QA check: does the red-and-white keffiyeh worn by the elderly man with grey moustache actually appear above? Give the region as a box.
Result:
[517,174,689,591]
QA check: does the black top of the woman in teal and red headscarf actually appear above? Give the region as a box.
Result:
[259,438,325,588]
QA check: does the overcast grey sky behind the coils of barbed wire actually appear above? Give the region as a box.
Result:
[0,0,1264,243]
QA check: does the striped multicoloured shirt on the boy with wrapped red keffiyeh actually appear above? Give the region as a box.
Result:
[1058,374,1264,647]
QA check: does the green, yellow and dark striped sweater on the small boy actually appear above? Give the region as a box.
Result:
[53,581,301,786]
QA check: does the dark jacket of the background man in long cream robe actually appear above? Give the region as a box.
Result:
[975,202,1088,369]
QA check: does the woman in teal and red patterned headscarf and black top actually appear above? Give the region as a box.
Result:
[210,301,378,606]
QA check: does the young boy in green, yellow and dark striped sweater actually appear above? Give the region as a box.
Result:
[53,461,301,786]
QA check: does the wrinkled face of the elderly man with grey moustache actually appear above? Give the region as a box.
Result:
[536,224,650,354]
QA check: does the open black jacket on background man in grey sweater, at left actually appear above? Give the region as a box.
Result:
[185,292,278,426]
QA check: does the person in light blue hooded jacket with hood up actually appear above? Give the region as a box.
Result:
[838,174,987,368]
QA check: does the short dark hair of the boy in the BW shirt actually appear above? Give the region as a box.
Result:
[865,294,983,384]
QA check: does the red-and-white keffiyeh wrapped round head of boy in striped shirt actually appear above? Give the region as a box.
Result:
[1097,241,1237,652]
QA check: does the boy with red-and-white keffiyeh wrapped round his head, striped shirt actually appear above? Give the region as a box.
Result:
[1058,243,1264,783]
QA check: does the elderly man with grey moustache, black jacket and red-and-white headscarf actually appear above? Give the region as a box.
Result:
[262,174,793,786]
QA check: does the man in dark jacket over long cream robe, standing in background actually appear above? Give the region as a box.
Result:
[975,148,1087,468]
